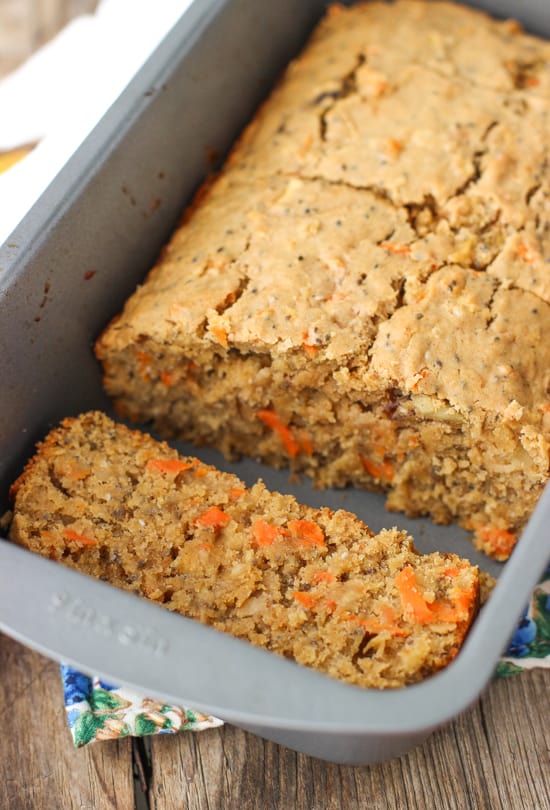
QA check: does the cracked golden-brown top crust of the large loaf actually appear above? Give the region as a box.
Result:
[97,0,550,434]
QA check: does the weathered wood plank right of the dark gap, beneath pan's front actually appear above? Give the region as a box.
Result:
[149,671,550,810]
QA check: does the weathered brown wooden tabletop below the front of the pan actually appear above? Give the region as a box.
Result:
[0,636,550,810]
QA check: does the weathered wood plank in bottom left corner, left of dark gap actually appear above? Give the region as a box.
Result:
[0,635,134,810]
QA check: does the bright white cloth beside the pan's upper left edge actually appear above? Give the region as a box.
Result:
[0,0,194,244]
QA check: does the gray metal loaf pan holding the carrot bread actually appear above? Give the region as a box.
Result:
[0,0,550,764]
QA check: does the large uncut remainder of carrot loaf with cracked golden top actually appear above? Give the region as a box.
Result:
[96,0,550,559]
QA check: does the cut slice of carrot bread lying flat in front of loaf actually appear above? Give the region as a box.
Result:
[9,413,479,688]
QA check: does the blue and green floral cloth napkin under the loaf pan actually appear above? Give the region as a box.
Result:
[61,566,550,747]
